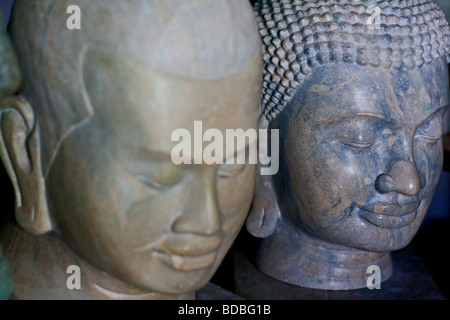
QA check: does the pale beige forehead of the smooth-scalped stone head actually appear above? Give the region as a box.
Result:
[82,46,261,154]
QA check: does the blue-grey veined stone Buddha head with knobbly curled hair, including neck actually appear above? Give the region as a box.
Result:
[247,0,450,290]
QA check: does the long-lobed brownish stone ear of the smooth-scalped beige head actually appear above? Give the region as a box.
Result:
[0,97,52,235]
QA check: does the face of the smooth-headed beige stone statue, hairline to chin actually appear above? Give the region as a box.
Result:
[47,49,261,294]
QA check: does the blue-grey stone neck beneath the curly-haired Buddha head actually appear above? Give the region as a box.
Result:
[256,221,392,290]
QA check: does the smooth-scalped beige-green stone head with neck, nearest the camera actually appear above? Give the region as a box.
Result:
[0,0,262,299]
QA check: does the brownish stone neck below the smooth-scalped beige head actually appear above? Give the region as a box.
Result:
[0,223,195,300]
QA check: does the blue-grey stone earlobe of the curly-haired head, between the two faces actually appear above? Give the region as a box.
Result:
[246,117,281,238]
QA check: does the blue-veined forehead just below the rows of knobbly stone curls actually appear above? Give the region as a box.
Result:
[294,59,449,124]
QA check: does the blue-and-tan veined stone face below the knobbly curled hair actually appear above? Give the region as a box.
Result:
[272,58,448,251]
